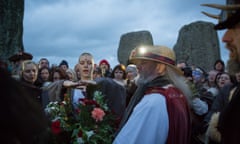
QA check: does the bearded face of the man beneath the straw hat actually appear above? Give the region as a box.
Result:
[136,60,157,83]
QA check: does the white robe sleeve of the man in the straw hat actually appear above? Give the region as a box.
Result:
[113,93,169,144]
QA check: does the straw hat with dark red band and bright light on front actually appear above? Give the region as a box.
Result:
[129,46,182,74]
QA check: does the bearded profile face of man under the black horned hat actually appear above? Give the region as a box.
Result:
[222,24,240,62]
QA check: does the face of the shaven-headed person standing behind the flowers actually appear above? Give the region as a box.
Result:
[79,55,94,80]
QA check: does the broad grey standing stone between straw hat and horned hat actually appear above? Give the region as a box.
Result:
[173,21,220,71]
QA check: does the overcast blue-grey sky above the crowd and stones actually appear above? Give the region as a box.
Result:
[23,0,228,68]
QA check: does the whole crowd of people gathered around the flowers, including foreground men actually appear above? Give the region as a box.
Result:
[0,0,240,144]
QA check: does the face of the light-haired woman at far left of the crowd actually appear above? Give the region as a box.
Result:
[22,63,38,83]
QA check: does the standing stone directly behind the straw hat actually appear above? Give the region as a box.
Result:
[118,31,153,66]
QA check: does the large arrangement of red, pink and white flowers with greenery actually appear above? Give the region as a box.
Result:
[45,91,116,144]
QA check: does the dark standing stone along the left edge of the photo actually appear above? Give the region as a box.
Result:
[0,0,24,60]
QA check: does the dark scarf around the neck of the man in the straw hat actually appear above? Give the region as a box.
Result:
[116,76,172,135]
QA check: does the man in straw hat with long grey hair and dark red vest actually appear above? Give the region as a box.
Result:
[113,46,191,144]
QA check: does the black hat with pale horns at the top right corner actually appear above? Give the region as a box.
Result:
[202,0,240,30]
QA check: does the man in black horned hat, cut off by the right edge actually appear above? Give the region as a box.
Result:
[203,0,240,144]
